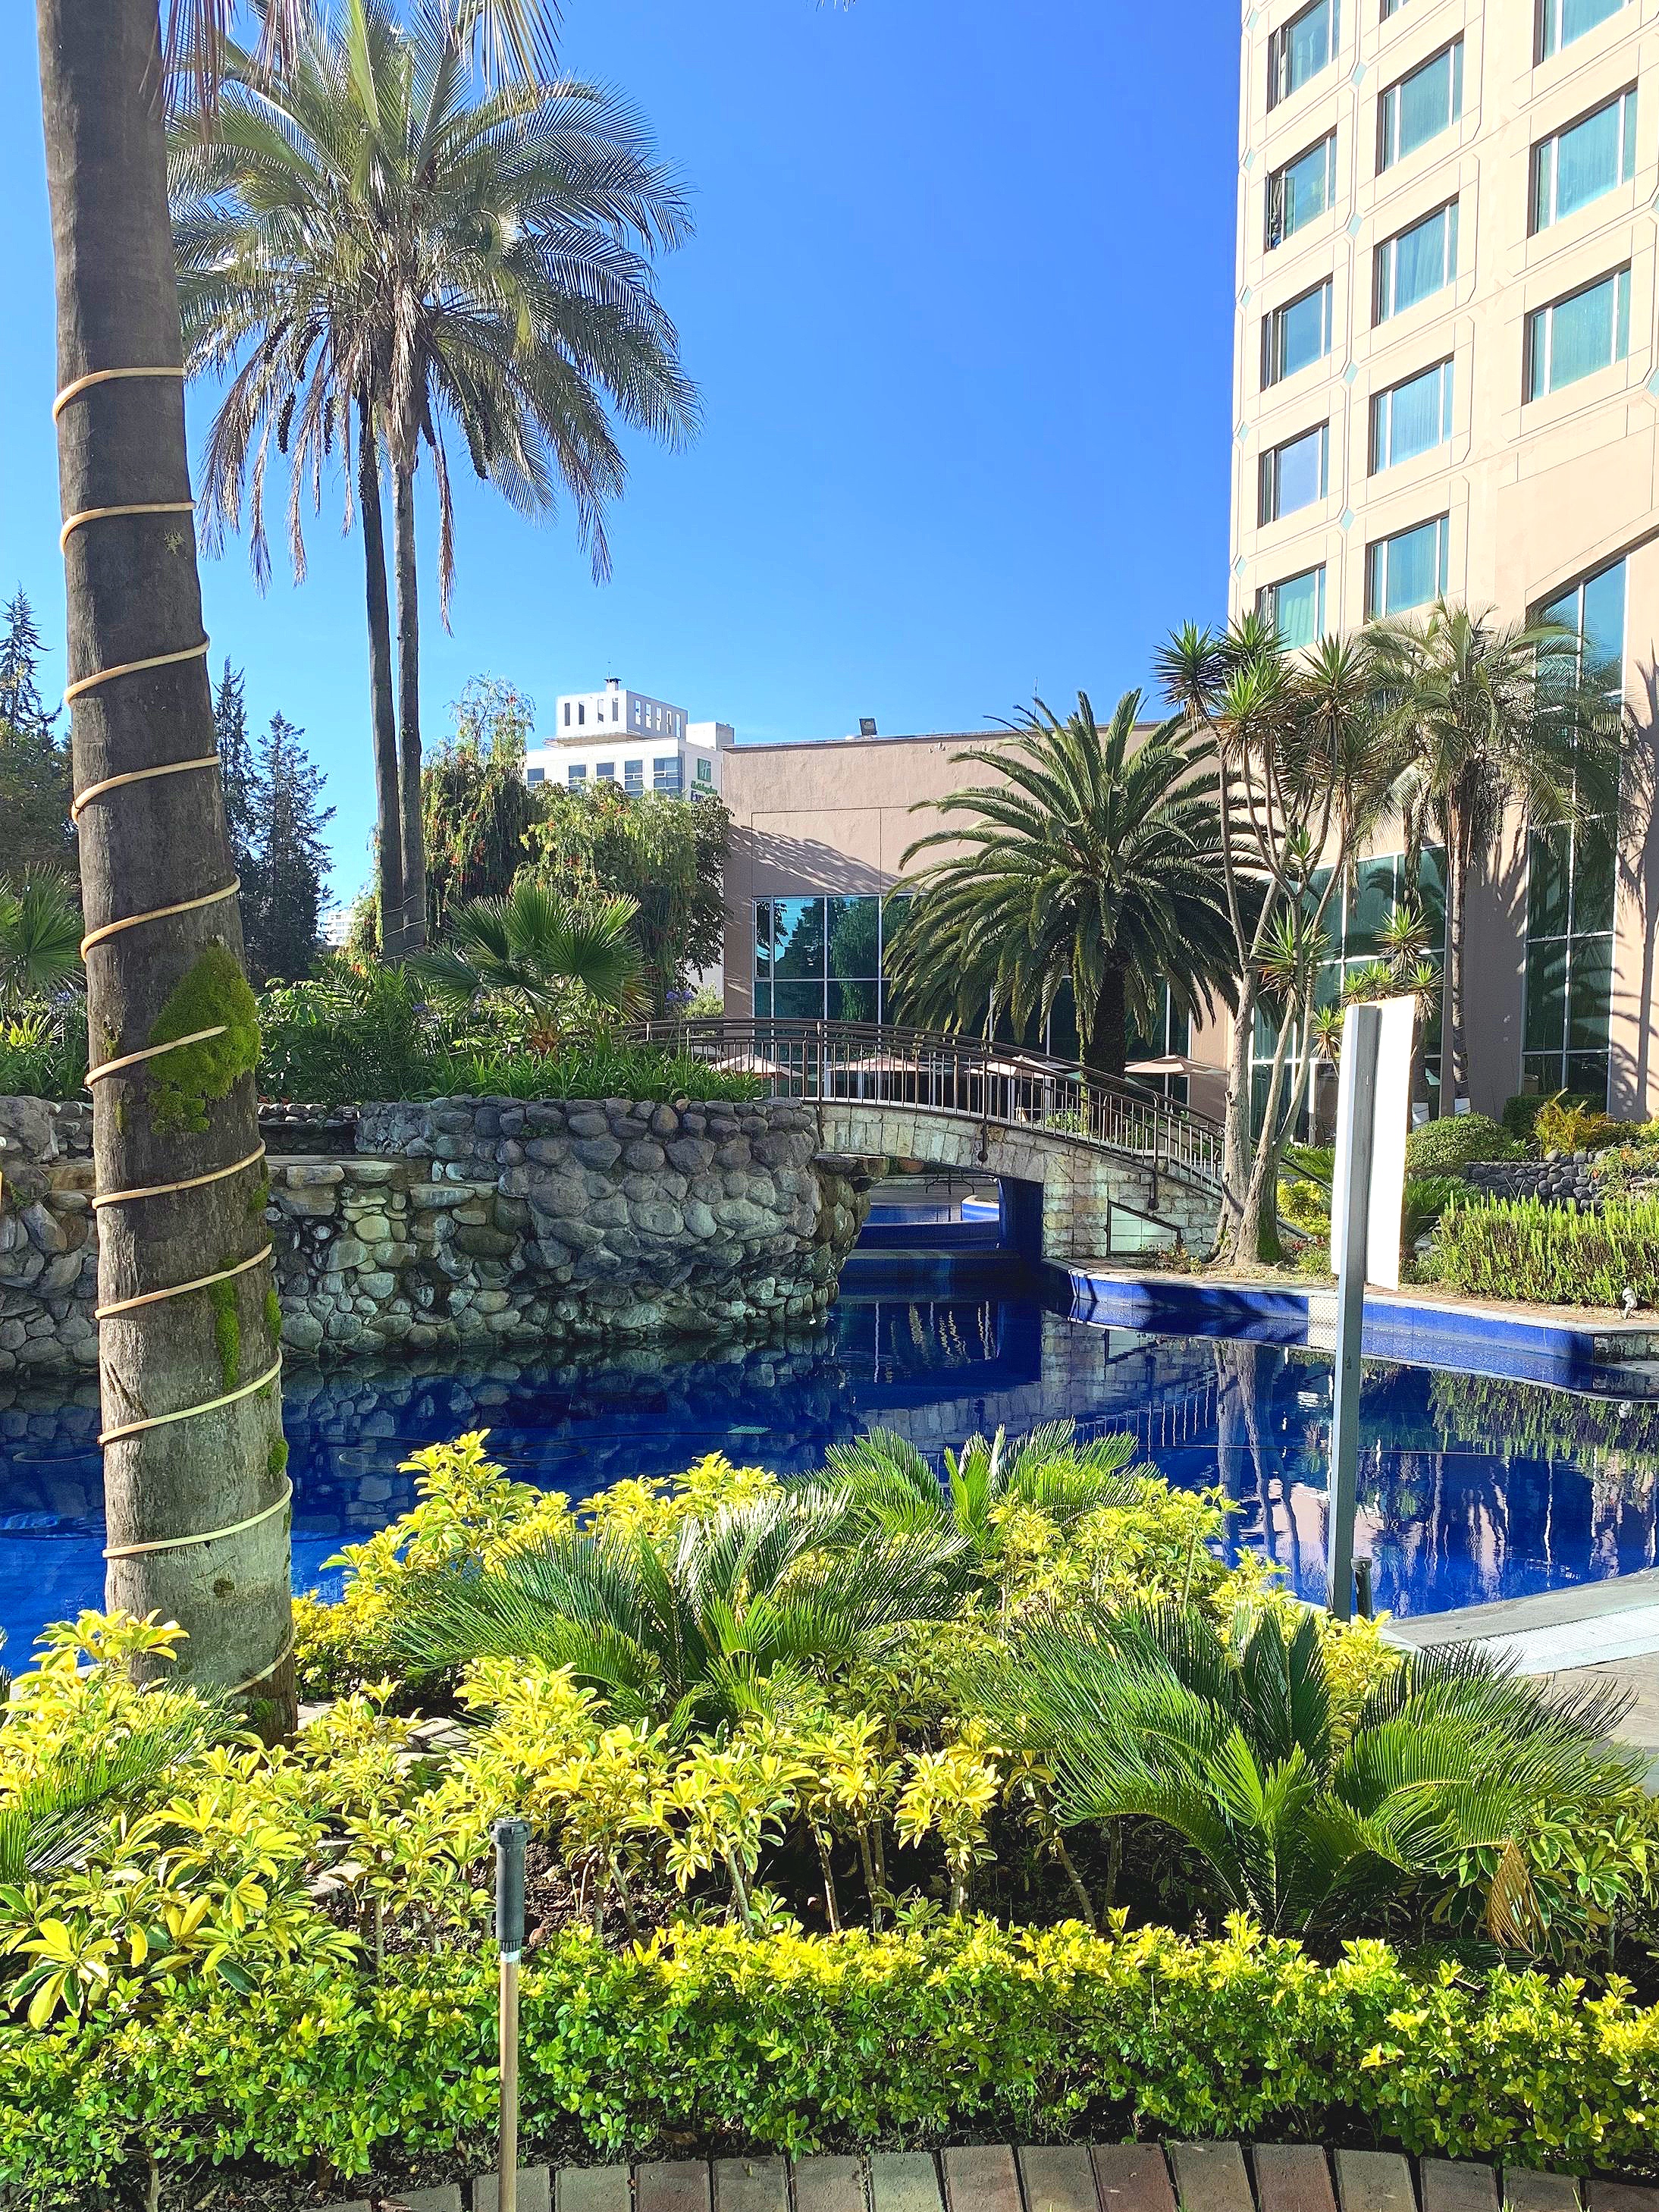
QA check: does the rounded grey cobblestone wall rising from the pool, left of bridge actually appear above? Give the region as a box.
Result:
[0,1100,867,1373]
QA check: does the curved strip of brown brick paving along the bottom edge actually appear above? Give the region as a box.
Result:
[338,2144,1659,2212]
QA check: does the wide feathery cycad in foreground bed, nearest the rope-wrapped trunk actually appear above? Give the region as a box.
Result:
[398,1493,964,1730]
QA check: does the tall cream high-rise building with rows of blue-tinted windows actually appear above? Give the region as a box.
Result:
[1232,0,1659,1115]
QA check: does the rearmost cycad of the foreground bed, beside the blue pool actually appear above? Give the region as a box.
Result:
[823,1420,1143,1559]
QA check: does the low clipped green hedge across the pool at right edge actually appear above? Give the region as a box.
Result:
[1435,1199,1659,1305]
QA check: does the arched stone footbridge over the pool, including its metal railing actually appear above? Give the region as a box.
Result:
[644,1020,1221,1263]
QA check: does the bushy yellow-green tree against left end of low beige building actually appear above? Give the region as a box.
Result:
[528,783,732,1011]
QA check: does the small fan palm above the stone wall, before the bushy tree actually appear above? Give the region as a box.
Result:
[409,878,651,1033]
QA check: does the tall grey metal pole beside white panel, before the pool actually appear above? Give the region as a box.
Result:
[1325,1006,1382,1621]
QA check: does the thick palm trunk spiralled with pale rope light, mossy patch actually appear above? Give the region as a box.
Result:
[38,0,294,1730]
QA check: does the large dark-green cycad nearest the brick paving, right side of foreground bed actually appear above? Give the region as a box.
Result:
[989,1606,1642,1942]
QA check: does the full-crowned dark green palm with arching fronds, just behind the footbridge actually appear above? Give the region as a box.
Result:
[894,692,1232,1075]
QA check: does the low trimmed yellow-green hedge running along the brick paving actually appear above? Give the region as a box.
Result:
[0,1920,1659,2203]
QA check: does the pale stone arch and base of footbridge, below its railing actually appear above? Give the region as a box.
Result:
[814,1100,1218,1266]
